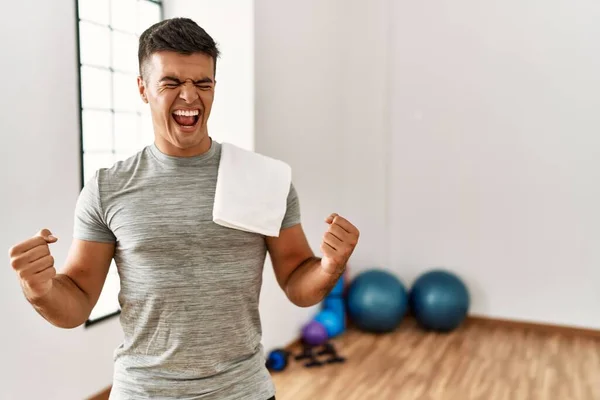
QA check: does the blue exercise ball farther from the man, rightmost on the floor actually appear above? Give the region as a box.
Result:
[409,269,470,332]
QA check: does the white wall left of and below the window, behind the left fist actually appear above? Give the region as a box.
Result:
[0,0,122,400]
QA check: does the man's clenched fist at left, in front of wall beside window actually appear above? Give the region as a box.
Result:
[9,229,58,299]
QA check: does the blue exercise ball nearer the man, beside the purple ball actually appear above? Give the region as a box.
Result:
[347,269,408,333]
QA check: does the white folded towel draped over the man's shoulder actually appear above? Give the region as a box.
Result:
[213,143,292,237]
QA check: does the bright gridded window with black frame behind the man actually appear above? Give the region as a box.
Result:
[76,0,163,325]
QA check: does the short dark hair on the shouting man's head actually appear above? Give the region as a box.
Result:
[138,18,220,76]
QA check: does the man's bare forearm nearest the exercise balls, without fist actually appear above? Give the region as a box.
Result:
[286,257,345,307]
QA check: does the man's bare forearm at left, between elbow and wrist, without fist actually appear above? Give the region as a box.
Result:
[24,274,91,329]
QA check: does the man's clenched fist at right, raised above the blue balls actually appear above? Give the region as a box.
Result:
[321,213,359,274]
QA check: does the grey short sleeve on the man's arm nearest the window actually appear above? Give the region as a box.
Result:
[73,172,116,243]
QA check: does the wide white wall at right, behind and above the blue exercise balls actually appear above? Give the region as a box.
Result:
[389,0,600,328]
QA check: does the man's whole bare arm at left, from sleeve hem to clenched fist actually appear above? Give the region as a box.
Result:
[9,229,115,328]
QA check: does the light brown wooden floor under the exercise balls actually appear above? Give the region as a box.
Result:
[272,320,600,400]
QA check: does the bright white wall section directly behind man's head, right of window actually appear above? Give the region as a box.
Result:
[163,0,254,150]
